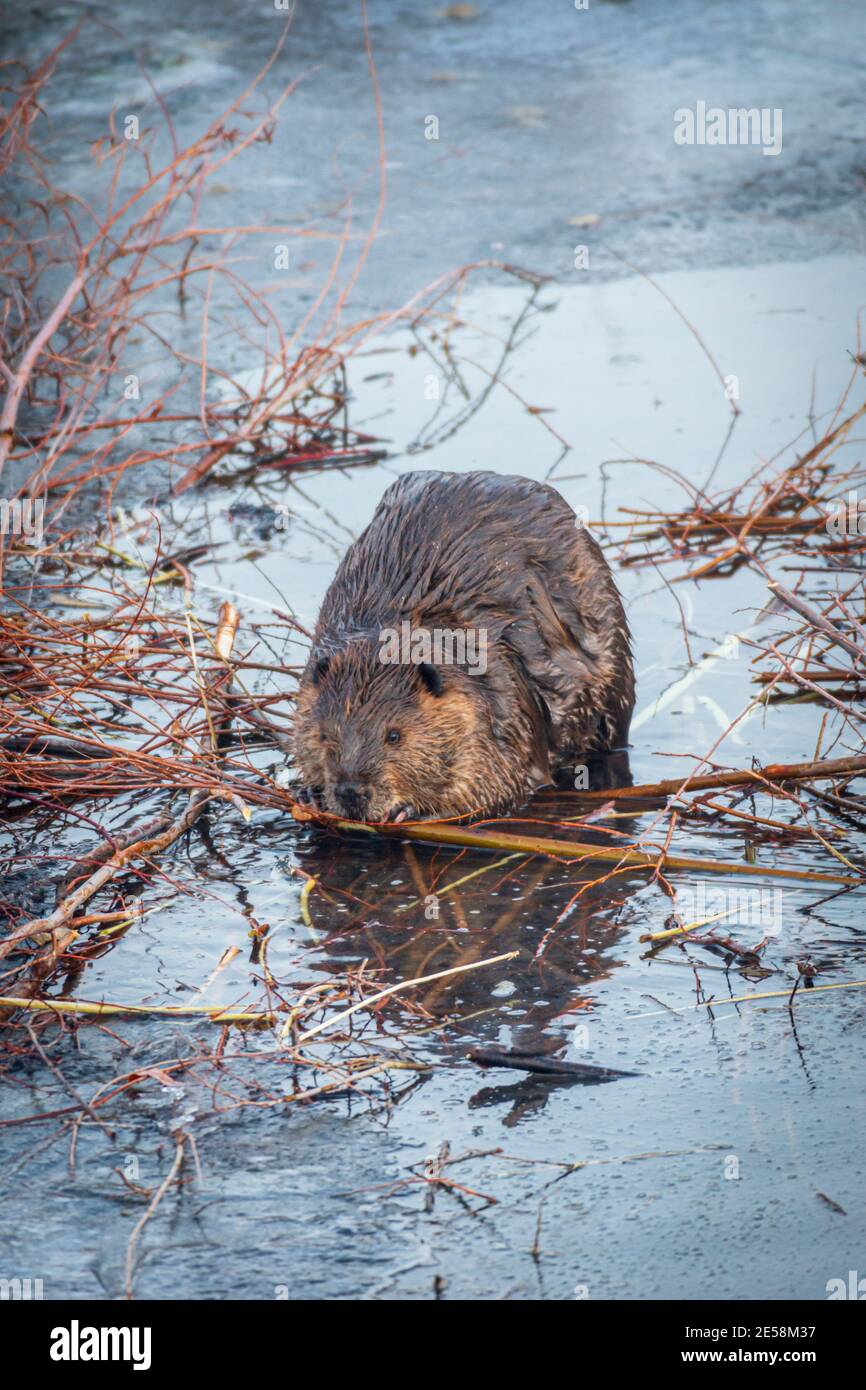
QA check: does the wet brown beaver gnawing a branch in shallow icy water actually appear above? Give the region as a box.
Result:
[293,471,634,821]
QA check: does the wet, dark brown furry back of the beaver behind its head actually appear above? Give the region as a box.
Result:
[316,471,634,748]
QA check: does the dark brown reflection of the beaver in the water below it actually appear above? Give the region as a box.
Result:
[291,769,645,1123]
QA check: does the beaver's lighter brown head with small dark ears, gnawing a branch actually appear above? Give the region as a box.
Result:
[295,641,528,820]
